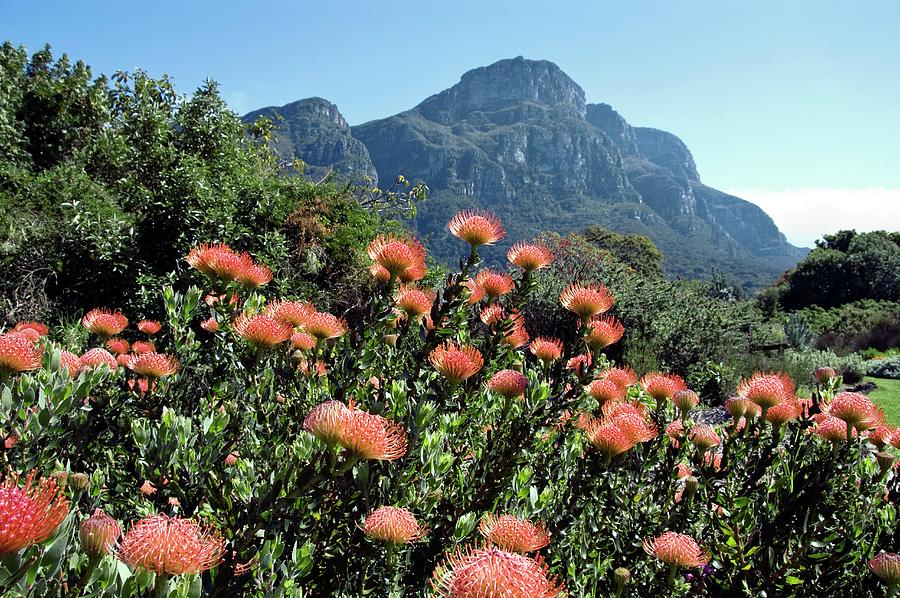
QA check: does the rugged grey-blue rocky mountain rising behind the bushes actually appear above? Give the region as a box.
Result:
[245,57,806,288]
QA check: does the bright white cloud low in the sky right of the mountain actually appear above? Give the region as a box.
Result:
[727,187,900,247]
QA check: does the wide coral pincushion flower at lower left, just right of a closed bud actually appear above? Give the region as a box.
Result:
[118,515,225,575]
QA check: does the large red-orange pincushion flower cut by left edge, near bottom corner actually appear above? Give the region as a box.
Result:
[0,471,69,555]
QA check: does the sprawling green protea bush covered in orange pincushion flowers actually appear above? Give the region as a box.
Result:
[0,211,900,598]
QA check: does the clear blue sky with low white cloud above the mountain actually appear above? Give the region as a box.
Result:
[0,0,900,244]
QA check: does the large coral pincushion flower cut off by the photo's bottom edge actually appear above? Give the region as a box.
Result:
[431,547,566,598]
